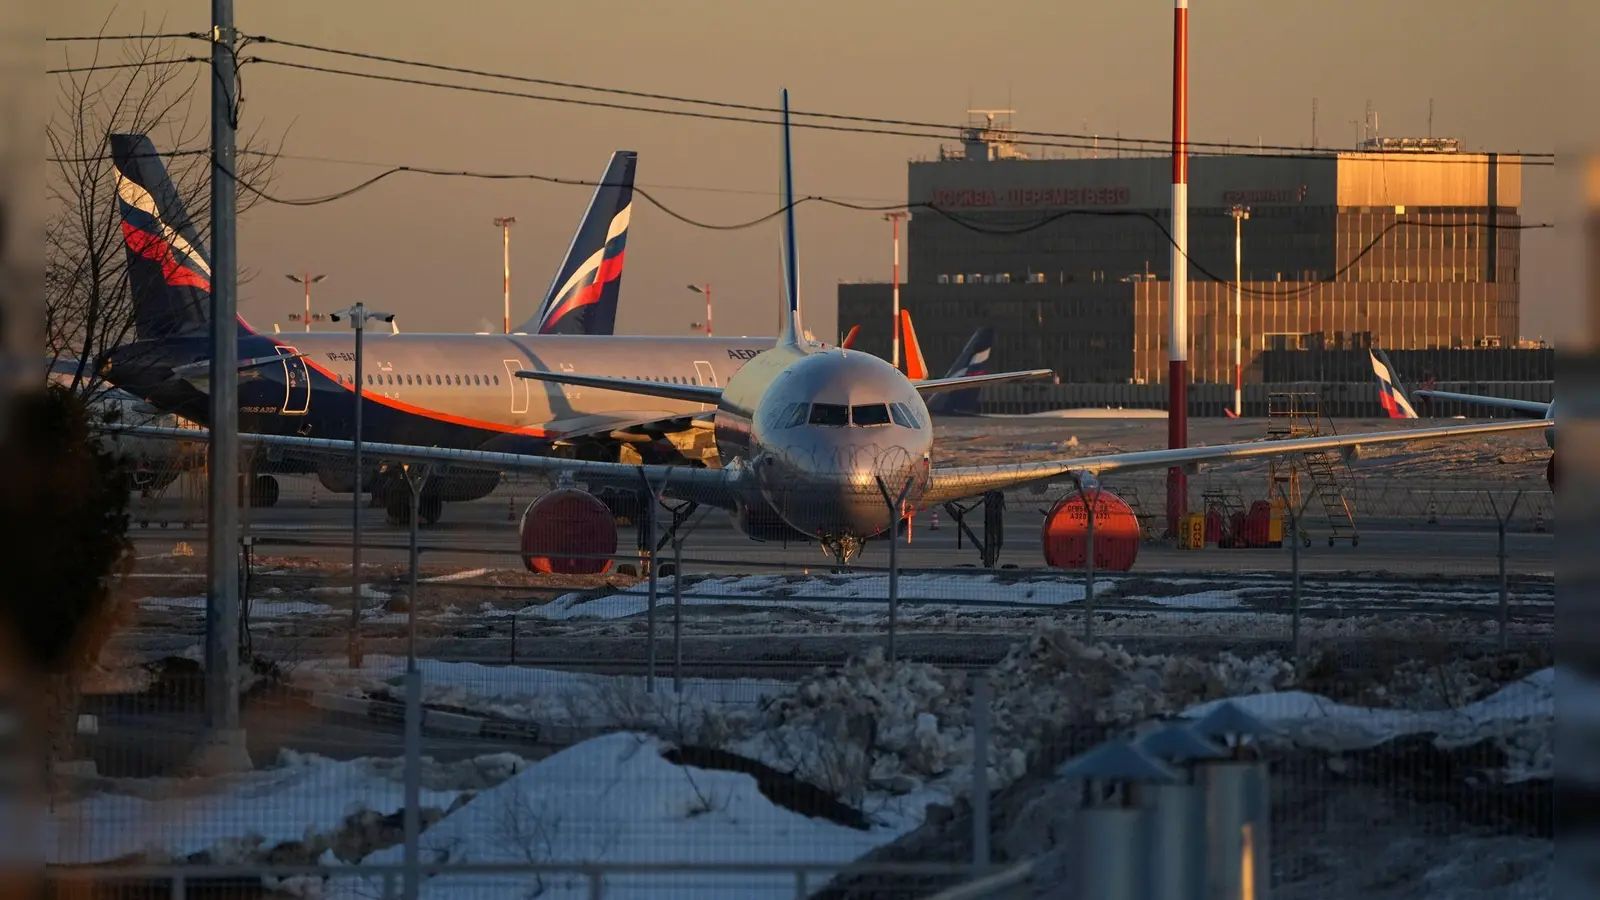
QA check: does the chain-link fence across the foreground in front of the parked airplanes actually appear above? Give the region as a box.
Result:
[75,445,1555,897]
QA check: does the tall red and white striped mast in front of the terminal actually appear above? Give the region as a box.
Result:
[1166,0,1189,536]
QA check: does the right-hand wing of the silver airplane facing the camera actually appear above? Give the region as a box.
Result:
[922,420,1550,506]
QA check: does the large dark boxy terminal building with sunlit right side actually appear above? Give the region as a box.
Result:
[838,114,1549,415]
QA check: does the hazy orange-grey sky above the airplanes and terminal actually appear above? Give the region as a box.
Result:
[46,0,1597,336]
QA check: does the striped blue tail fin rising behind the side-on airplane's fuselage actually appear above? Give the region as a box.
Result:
[517,151,638,335]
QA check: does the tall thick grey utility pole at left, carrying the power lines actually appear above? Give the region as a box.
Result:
[197,0,250,772]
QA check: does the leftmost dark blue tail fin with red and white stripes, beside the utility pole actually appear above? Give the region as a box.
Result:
[109,135,253,340]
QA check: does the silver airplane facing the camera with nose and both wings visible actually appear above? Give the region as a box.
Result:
[109,90,1549,565]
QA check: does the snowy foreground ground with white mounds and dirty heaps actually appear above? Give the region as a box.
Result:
[68,626,1555,897]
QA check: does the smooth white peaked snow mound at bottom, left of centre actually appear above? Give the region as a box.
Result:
[323,733,898,900]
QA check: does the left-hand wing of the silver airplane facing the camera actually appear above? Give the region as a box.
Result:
[98,426,746,509]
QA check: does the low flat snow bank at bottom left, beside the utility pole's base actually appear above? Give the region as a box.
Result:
[43,751,526,865]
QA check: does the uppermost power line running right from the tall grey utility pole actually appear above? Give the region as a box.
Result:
[250,35,1555,165]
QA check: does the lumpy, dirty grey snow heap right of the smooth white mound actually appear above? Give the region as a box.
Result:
[731,625,1293,802]
